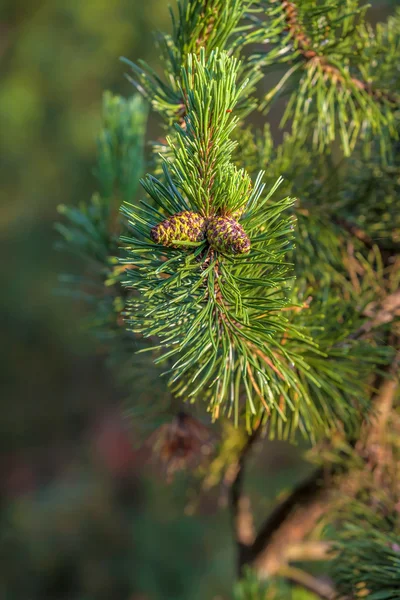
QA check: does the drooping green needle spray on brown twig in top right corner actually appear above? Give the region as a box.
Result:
[253,0,399,156]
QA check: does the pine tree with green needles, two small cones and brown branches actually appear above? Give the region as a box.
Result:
[57,0,400,600]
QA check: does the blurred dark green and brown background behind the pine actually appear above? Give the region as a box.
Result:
[0,0,392,600]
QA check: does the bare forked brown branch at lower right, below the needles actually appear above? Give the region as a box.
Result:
[225,351,400,600]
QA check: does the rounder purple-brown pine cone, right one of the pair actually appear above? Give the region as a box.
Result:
[207,217,250,254]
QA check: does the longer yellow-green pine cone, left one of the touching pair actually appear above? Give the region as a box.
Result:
[150,210,206,248]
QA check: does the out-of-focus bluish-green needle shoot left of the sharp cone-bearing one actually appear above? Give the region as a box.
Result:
[56,92,152,380]
